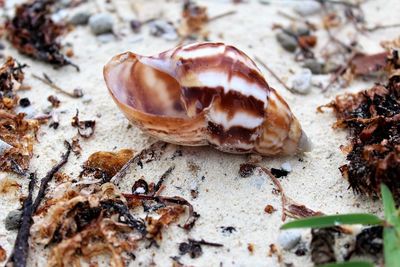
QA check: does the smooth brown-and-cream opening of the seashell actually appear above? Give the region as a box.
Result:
[104,53,188,118]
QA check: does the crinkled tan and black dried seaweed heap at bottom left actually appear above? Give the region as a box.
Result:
[33,183,146,266]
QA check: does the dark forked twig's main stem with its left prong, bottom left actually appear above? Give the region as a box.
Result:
[6,173,36,267]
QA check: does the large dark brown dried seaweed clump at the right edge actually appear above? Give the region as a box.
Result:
[325,52,400,204]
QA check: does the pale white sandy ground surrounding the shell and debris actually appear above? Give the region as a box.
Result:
[0,0,400,266]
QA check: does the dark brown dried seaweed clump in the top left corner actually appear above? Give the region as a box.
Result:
[6,0,79,70]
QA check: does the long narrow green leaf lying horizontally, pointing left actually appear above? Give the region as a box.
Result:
[281,213,383,229]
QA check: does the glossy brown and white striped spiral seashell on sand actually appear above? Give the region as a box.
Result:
[104,43,310,155]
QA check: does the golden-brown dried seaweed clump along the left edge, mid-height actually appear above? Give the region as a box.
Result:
[0,58,40,174]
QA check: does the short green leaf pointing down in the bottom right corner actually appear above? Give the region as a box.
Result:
[383,227,400,267]
